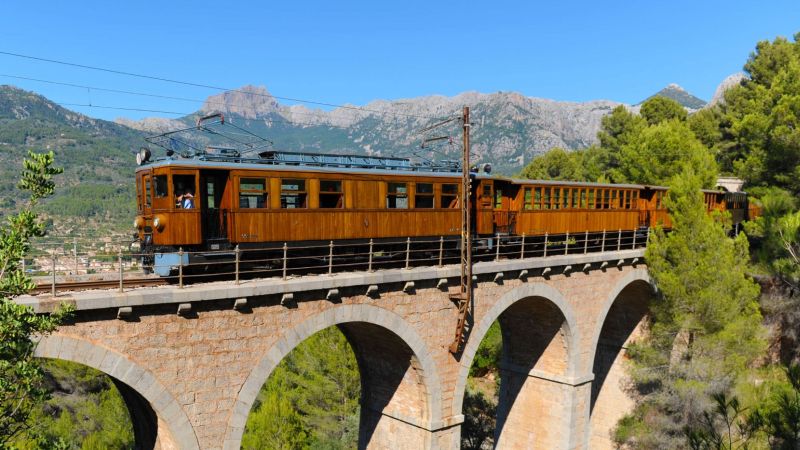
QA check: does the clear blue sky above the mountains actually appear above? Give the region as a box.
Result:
[0,0,800,119]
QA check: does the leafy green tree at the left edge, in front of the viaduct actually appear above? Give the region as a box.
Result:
[0,152,68,447]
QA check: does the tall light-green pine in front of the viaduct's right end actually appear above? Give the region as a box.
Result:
[616,168,764,448]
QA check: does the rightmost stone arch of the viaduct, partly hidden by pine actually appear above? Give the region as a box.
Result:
[586,269,653,449]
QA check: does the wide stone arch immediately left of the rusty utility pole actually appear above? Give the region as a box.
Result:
[224,304,442,449]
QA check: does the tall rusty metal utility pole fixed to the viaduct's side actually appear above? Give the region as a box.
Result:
[449,106,472,354]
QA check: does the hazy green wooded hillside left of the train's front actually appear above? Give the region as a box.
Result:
[0,86,142,239]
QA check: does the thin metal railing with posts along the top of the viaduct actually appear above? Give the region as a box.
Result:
[23,228,650,295]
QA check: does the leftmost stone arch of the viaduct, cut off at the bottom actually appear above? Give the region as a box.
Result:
[34,334,200,449]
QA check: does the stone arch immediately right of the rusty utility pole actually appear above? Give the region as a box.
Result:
[453,283,580,448]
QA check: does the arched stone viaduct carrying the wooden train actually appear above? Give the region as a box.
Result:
[18,249,652,449]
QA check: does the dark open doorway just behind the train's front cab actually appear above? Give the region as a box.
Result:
[199,170,229,250]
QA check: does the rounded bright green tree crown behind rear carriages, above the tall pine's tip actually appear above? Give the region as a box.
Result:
[614,120,717,188]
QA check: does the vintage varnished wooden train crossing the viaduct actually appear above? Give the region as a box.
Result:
[132,146,752,275]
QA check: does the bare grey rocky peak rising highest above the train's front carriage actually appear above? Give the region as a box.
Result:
[200,85,280,119]
